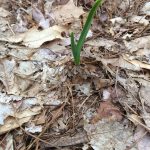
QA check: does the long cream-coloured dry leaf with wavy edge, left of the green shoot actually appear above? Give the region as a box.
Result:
[0,26,66,48]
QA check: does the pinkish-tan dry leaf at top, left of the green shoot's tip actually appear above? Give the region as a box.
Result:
[50,0,85,24]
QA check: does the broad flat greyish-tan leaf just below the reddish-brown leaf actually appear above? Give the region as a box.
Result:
[84,119,137,150]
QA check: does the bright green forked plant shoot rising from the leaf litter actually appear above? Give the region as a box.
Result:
[71,0,102,65]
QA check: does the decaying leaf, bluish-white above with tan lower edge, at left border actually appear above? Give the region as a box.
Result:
[0,93,41,134]
